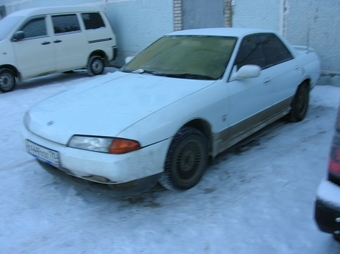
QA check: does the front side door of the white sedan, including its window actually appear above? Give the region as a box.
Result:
[223,35,273,149]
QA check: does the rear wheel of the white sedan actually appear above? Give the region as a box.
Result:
[288,83,309,122]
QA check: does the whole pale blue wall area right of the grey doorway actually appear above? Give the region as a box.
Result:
[233,0,340,85]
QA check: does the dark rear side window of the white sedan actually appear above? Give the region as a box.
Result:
[260,34,293,68]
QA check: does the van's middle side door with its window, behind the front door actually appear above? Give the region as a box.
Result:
[51,14,89,71]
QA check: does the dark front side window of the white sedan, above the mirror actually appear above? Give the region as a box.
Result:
[235,35,265,69]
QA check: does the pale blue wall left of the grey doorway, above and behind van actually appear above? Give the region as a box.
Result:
[0,0,174,66]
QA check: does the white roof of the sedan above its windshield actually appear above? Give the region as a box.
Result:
[167,28,274,37]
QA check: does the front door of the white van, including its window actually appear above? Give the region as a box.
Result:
[12,16,55,79]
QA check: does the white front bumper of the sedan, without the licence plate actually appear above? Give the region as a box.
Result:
[22,127,171,184]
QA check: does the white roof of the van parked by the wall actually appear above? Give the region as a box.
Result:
[8,5,102,16]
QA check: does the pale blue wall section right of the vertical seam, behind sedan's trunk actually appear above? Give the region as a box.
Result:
[285,0,340,86]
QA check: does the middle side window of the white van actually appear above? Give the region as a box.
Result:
[52,14,80,34]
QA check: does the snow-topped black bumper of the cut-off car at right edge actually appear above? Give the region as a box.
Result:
[314,180,340,235]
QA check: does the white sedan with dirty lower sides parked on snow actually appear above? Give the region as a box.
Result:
[23,28,320,189]
